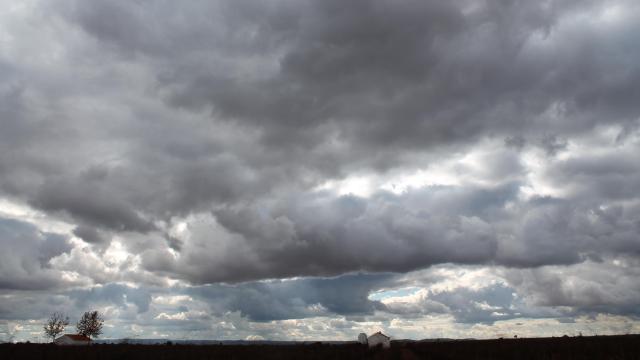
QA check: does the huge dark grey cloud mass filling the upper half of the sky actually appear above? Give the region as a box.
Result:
[0,1,638,228]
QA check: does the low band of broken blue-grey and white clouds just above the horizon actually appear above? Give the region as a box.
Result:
[0,258,638,338]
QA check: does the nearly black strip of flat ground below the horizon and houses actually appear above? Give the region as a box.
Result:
[0,335,640,360]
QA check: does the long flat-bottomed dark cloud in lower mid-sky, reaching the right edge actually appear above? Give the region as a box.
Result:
[143,176,640,283]
